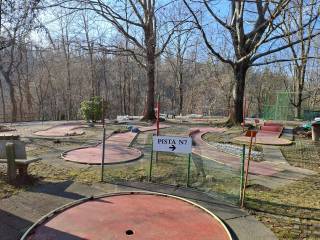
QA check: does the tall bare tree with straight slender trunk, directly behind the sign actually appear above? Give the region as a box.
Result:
[61,0,180,120]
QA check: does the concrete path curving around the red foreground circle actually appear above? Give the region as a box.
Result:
[0,181,276,240]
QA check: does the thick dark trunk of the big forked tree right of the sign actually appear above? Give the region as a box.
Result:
[228,63,248,124]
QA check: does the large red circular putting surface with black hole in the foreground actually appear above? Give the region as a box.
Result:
[26,193,231,240]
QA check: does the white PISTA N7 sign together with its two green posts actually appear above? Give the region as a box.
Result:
[149,135,192,187]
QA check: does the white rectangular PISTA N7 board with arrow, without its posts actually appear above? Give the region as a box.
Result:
[152,136,192,154]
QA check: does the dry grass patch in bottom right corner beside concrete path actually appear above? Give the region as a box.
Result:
[246,175,320,240]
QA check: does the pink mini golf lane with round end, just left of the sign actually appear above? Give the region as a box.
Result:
[62,125,169,165]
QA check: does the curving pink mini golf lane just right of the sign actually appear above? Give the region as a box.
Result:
[192,129,278,176]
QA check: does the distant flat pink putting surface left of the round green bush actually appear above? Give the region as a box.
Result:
[34,124,84,137]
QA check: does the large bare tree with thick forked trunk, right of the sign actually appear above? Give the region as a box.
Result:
[183,0,319,123]
